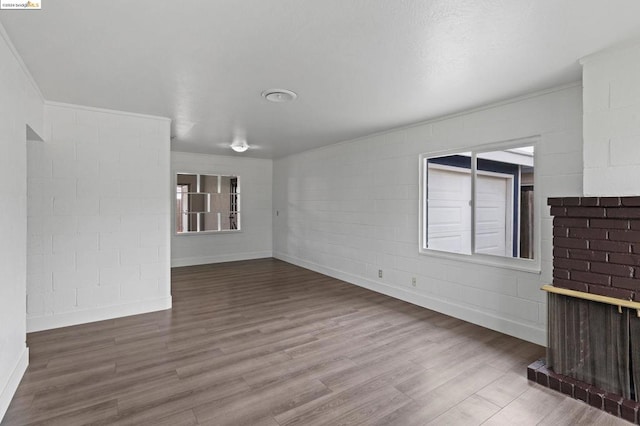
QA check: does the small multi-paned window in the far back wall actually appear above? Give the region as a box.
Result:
[176,173,240,234]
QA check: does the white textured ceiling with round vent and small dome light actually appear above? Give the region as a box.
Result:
[0,0,640,158]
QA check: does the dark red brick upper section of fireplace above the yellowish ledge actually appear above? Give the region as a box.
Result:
[549,197,640,300]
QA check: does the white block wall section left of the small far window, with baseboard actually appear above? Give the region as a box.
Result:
[27,103,171,331]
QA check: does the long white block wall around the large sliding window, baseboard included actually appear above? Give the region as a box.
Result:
[273,85,582,344]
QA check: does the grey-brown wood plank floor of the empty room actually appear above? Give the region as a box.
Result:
[2,259,626,426]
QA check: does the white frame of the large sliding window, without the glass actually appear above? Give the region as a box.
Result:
[418,136,543,273]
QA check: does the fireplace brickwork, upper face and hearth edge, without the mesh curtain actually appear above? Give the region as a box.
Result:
[527,197,640,424]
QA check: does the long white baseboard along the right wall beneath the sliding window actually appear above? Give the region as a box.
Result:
[274,252,547,346]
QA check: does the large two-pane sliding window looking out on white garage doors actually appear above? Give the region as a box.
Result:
[420,145,536,259]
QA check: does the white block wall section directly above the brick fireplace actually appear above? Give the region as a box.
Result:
[582,41,640,196]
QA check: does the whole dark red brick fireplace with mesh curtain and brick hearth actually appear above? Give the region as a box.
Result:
[528,197,640,423]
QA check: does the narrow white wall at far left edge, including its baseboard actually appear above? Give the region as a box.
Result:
[0,25,43,420]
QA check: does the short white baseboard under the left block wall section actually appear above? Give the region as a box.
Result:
[27,296,171,333]
